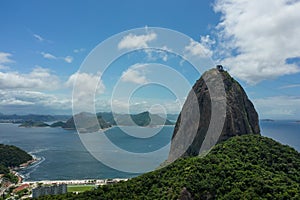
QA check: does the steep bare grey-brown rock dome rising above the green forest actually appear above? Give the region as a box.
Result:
[167,69,260,162]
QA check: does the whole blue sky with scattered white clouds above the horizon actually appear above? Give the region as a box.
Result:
[0,0,300,119]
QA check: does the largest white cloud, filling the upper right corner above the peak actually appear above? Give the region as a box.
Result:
[214,0,300,84]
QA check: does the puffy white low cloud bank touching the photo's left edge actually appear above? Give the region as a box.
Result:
[0,67,60,90]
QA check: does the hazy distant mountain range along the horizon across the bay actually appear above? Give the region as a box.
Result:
[5,111,178,132]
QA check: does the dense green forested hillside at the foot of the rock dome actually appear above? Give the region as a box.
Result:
[38,134,300,200]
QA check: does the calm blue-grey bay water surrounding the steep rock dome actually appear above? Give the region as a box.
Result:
[0,120,300,181]
